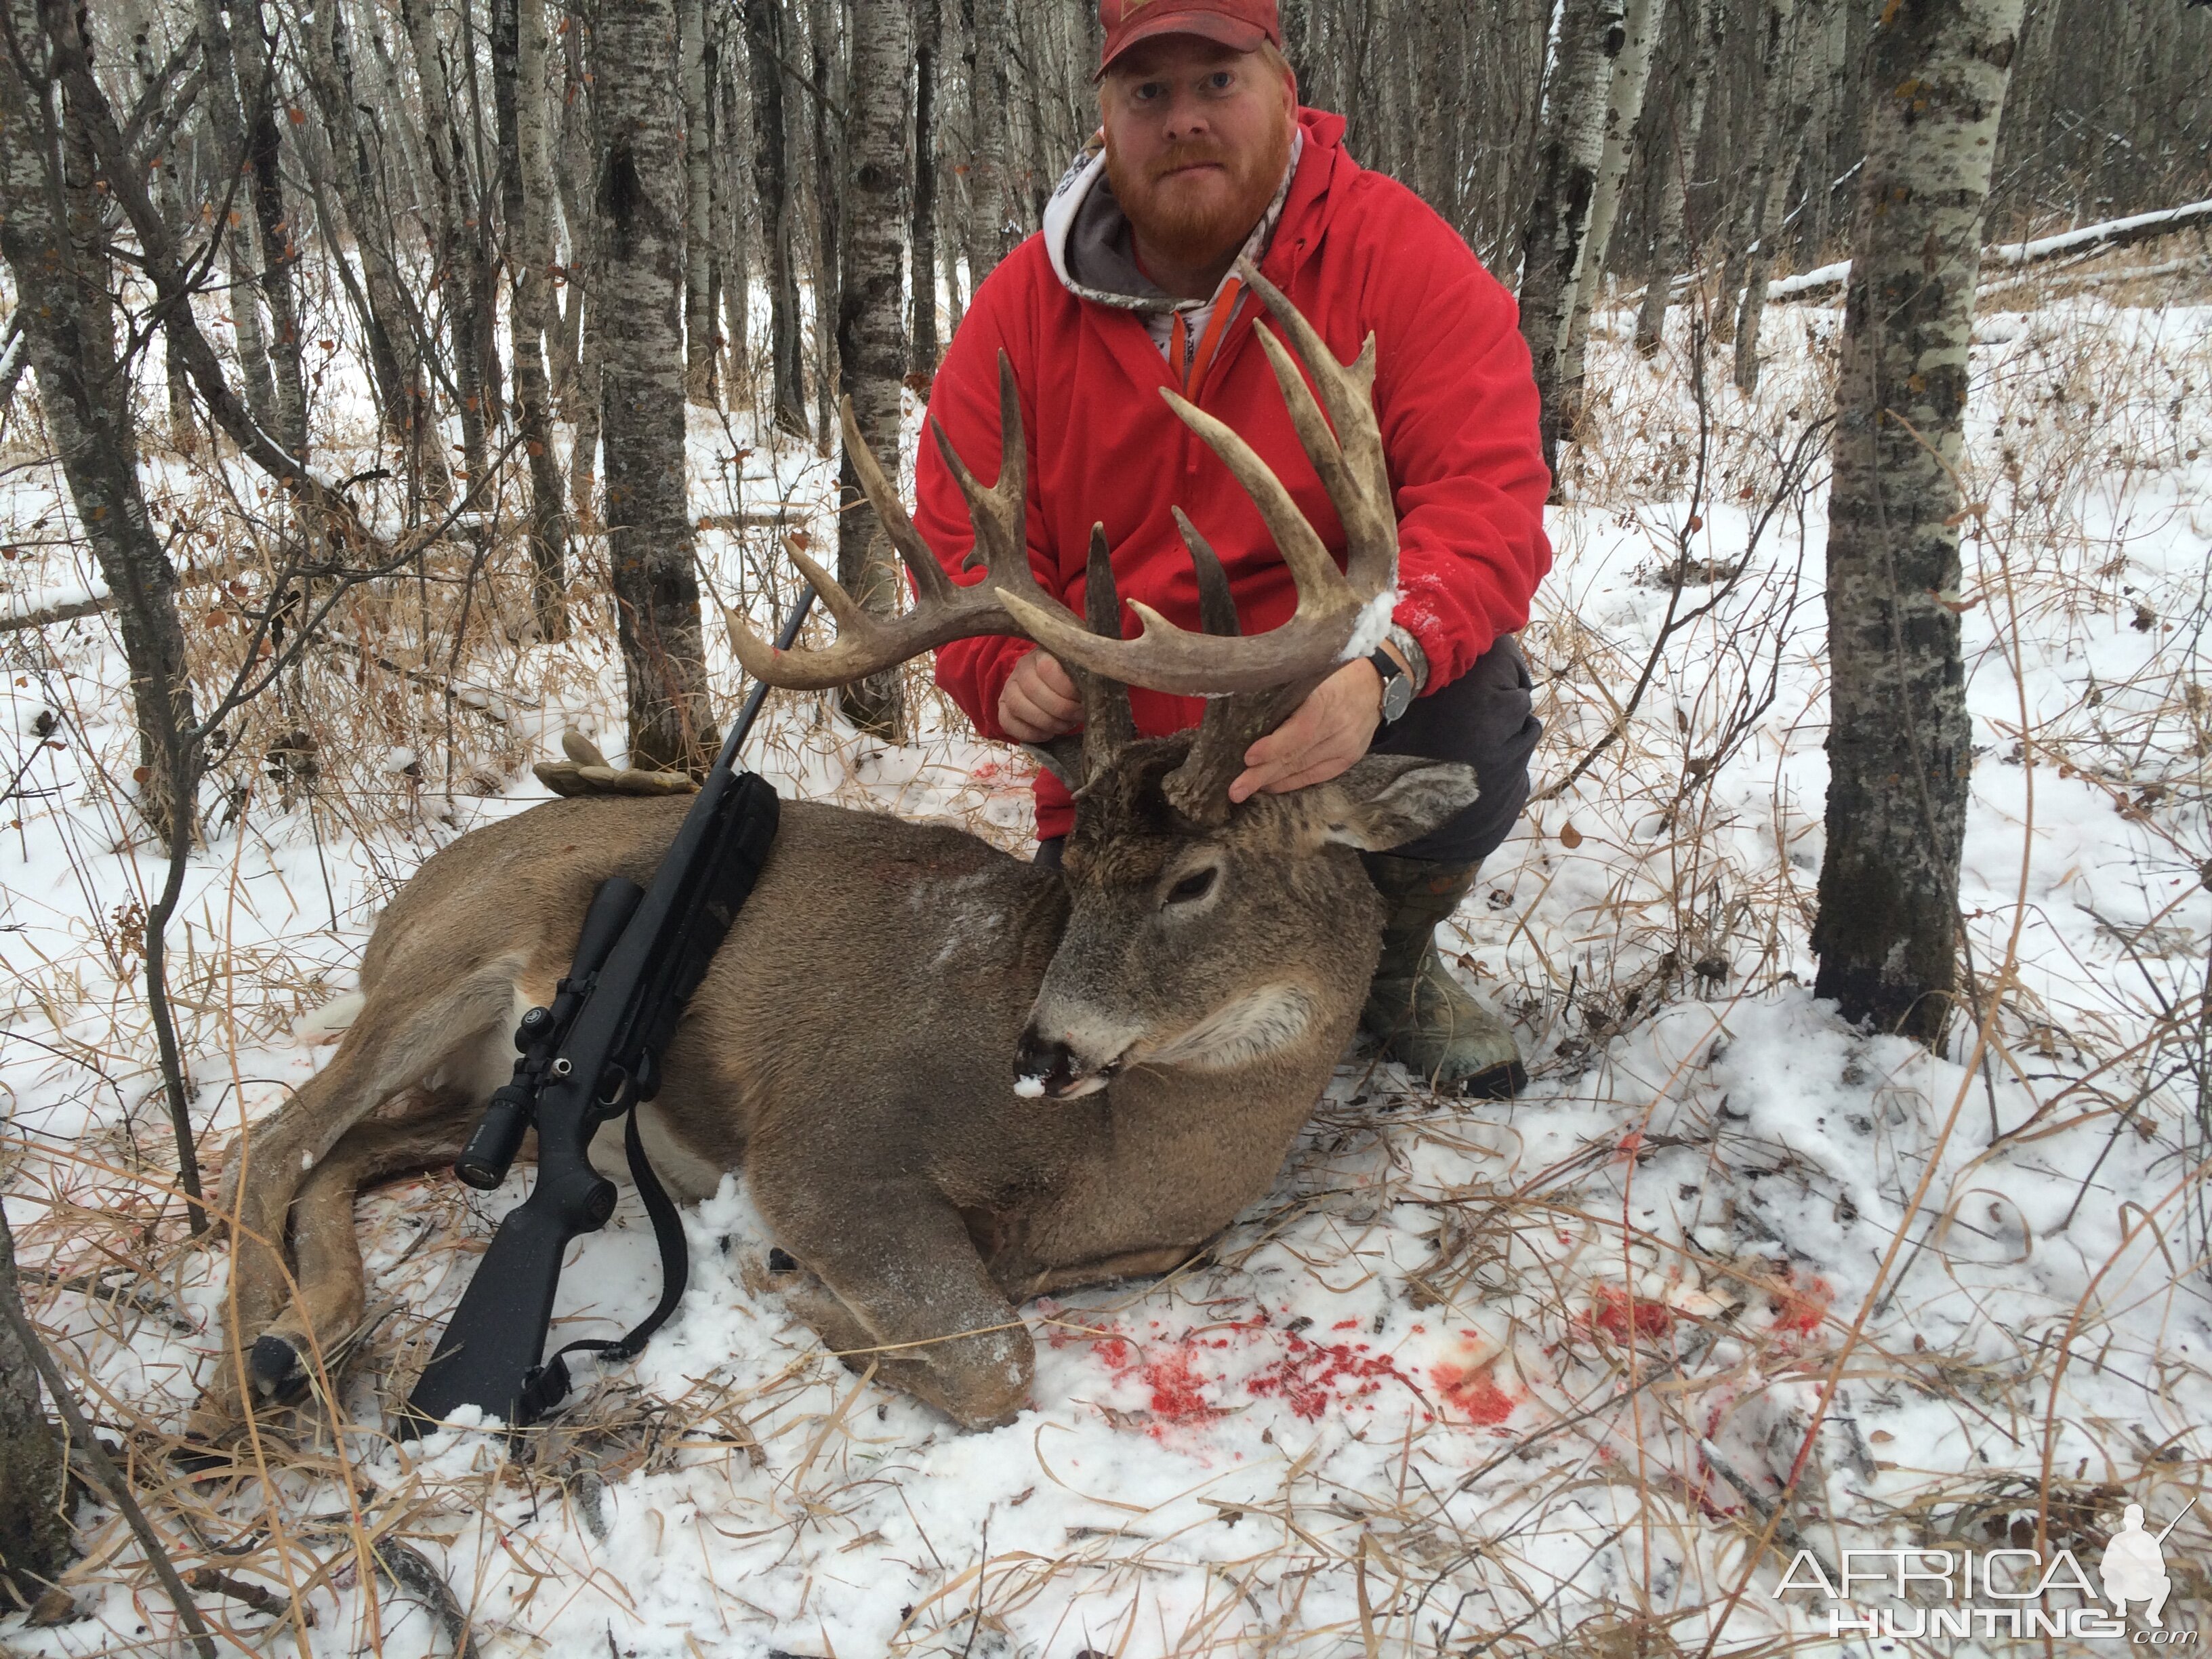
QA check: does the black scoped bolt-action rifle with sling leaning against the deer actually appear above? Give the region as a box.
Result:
[401,593,814,1435]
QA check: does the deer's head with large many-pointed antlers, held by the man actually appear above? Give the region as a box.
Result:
[728,263,1475,1097]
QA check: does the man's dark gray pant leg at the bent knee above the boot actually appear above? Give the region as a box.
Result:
[1372,635,1544,865]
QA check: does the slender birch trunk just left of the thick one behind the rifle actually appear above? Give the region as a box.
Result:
[491,0,569,639]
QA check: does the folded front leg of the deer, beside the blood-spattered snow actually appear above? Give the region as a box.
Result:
[754,1170,1036,1429]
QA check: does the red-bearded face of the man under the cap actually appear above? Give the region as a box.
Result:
[1099,35,1296,266]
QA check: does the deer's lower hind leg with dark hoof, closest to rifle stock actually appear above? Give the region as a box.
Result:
[245,1110,471,1400]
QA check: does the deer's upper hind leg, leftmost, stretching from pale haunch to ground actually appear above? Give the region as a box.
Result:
[192,962,520,1438]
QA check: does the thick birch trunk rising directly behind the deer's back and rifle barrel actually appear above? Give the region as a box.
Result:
[590,0,719,774]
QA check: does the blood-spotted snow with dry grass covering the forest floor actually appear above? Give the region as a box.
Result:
[0,266,2212,1659]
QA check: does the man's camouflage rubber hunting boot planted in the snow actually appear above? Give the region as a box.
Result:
[1360,852,1528,1099]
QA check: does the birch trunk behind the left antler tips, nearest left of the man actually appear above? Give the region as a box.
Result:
[836,0,927,737]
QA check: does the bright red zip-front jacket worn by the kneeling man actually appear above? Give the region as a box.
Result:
[914,110,1551,836]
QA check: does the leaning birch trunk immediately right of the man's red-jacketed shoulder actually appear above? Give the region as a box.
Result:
[1519,0,1628,473]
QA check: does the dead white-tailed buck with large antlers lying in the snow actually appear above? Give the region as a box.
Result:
[197,272,1475,1435]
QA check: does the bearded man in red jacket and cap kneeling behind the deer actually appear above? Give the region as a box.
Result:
[916,0,1551,1097]
